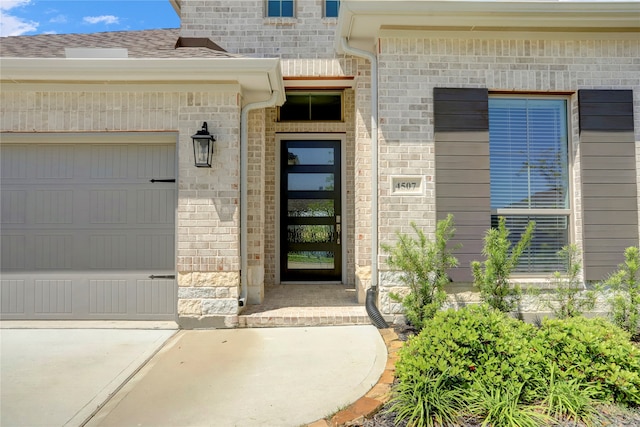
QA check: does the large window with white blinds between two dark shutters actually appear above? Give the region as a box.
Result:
[489,97,571,273]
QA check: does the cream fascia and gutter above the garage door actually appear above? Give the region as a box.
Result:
[0,58,284,105]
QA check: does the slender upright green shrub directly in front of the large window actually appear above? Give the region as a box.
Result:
[471,217,535,312]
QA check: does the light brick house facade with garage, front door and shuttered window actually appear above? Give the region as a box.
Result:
[0,0,640,327]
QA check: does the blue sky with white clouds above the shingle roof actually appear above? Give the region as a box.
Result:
[0,0,180,37]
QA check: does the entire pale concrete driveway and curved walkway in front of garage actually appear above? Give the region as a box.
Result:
[0,325,387,427]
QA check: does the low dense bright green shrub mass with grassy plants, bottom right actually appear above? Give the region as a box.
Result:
[392,304,640,427]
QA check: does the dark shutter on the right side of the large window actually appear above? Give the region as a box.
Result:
[578,90,638,281]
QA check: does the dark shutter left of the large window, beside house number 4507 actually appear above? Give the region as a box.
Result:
[433,88,491,282]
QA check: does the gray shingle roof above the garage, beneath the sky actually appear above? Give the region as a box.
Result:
[0,28,242,58]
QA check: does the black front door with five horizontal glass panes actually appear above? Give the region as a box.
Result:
[280,140,342,281]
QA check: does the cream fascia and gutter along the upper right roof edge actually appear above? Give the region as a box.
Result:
[336,0,640,53]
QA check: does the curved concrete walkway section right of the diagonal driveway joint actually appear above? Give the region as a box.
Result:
[87,325,387,427]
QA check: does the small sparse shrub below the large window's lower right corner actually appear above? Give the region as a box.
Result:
[540,245,596,319]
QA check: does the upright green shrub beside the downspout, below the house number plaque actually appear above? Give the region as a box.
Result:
[382,214,458,330]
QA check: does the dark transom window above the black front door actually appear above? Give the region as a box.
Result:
[278,91,343,121]
